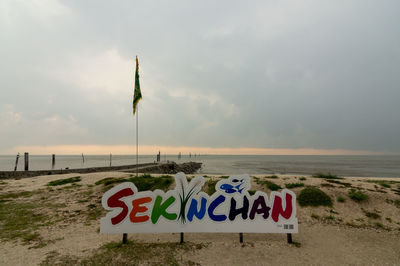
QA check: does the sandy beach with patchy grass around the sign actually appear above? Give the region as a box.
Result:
[0,172,400,265]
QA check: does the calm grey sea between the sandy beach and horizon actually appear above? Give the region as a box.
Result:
[0,155,400,178]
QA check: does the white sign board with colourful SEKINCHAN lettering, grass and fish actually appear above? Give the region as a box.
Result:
[100,173,298,234]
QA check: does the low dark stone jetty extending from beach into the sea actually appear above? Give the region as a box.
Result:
[0,162,201,179]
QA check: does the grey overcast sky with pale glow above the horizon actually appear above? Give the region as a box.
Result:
[0,0,400,154]
